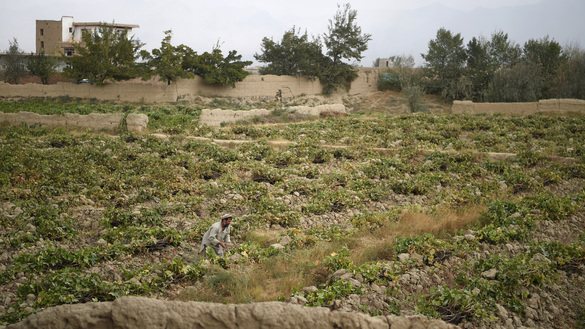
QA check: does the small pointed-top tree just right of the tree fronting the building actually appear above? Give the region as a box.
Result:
[140,30,195,84]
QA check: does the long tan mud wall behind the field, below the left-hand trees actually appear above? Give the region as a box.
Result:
[0,68,378,103]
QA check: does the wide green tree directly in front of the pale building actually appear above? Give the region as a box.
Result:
[62,24,143,85]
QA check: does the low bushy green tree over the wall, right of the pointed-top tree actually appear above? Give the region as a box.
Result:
[182,44,252,87]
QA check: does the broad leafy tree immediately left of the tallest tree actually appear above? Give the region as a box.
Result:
[254,26,324,78]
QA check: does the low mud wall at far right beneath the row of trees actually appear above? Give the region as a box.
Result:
[451,98,585,115]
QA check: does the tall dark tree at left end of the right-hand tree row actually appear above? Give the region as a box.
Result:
[421,28,471,100]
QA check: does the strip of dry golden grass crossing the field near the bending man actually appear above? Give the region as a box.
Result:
[177,206,485,304]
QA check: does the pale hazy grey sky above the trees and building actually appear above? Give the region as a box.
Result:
[0,0,585,66]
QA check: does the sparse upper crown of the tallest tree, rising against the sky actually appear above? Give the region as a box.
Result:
[323,3,372,64]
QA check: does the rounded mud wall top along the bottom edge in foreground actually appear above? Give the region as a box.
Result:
[7,297,458,329]
